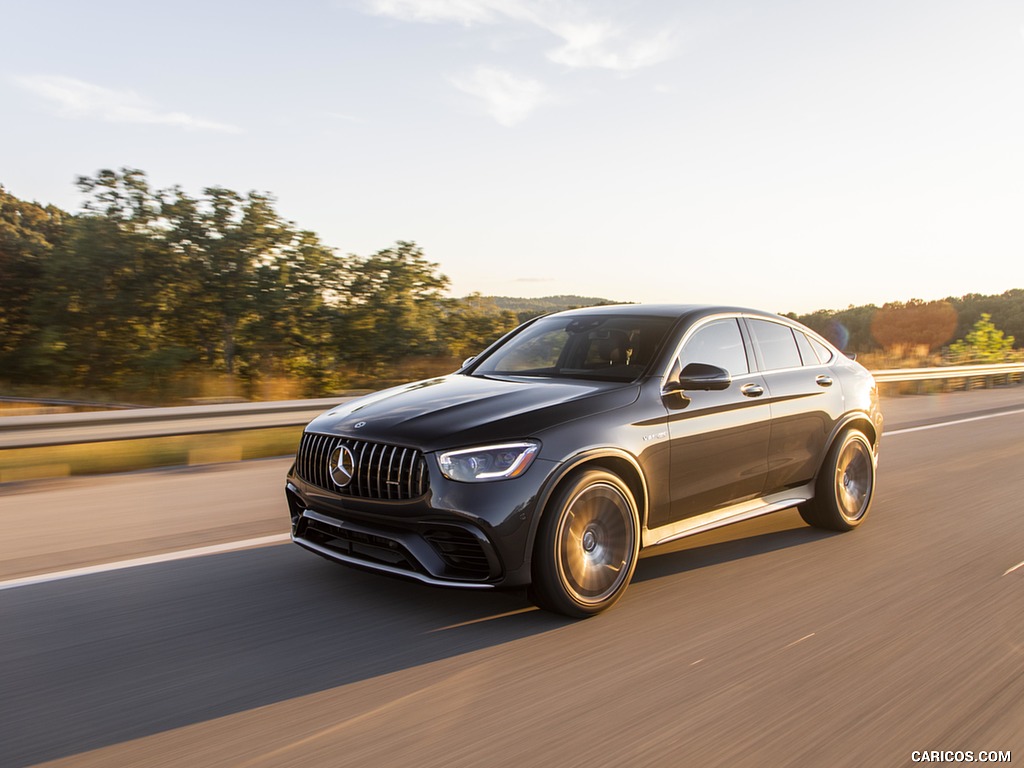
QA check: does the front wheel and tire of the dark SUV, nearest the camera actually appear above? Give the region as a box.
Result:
[530,470,640,618]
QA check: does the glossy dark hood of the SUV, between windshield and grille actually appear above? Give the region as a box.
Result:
[307,374,640,452]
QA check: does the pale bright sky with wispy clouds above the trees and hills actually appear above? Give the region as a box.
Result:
[0,0,1024,312]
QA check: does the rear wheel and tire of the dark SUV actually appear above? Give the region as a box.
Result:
[799,429,874,530]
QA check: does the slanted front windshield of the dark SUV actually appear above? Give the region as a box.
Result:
[471,314,675,381]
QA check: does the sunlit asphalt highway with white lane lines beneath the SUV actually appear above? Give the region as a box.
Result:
[0,387,1024,768]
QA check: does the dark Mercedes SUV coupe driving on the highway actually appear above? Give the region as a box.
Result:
[287,305,882,616]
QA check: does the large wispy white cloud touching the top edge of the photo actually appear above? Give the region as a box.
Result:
[369,0,676,72]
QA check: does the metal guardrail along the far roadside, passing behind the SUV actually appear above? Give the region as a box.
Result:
[0,362,1024,451]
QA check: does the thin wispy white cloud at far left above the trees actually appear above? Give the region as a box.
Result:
[12,75,240,133]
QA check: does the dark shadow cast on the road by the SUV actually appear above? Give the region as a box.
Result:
[0,507,821,766]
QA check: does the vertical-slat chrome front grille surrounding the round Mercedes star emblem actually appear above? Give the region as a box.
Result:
[295,432,429,501]
